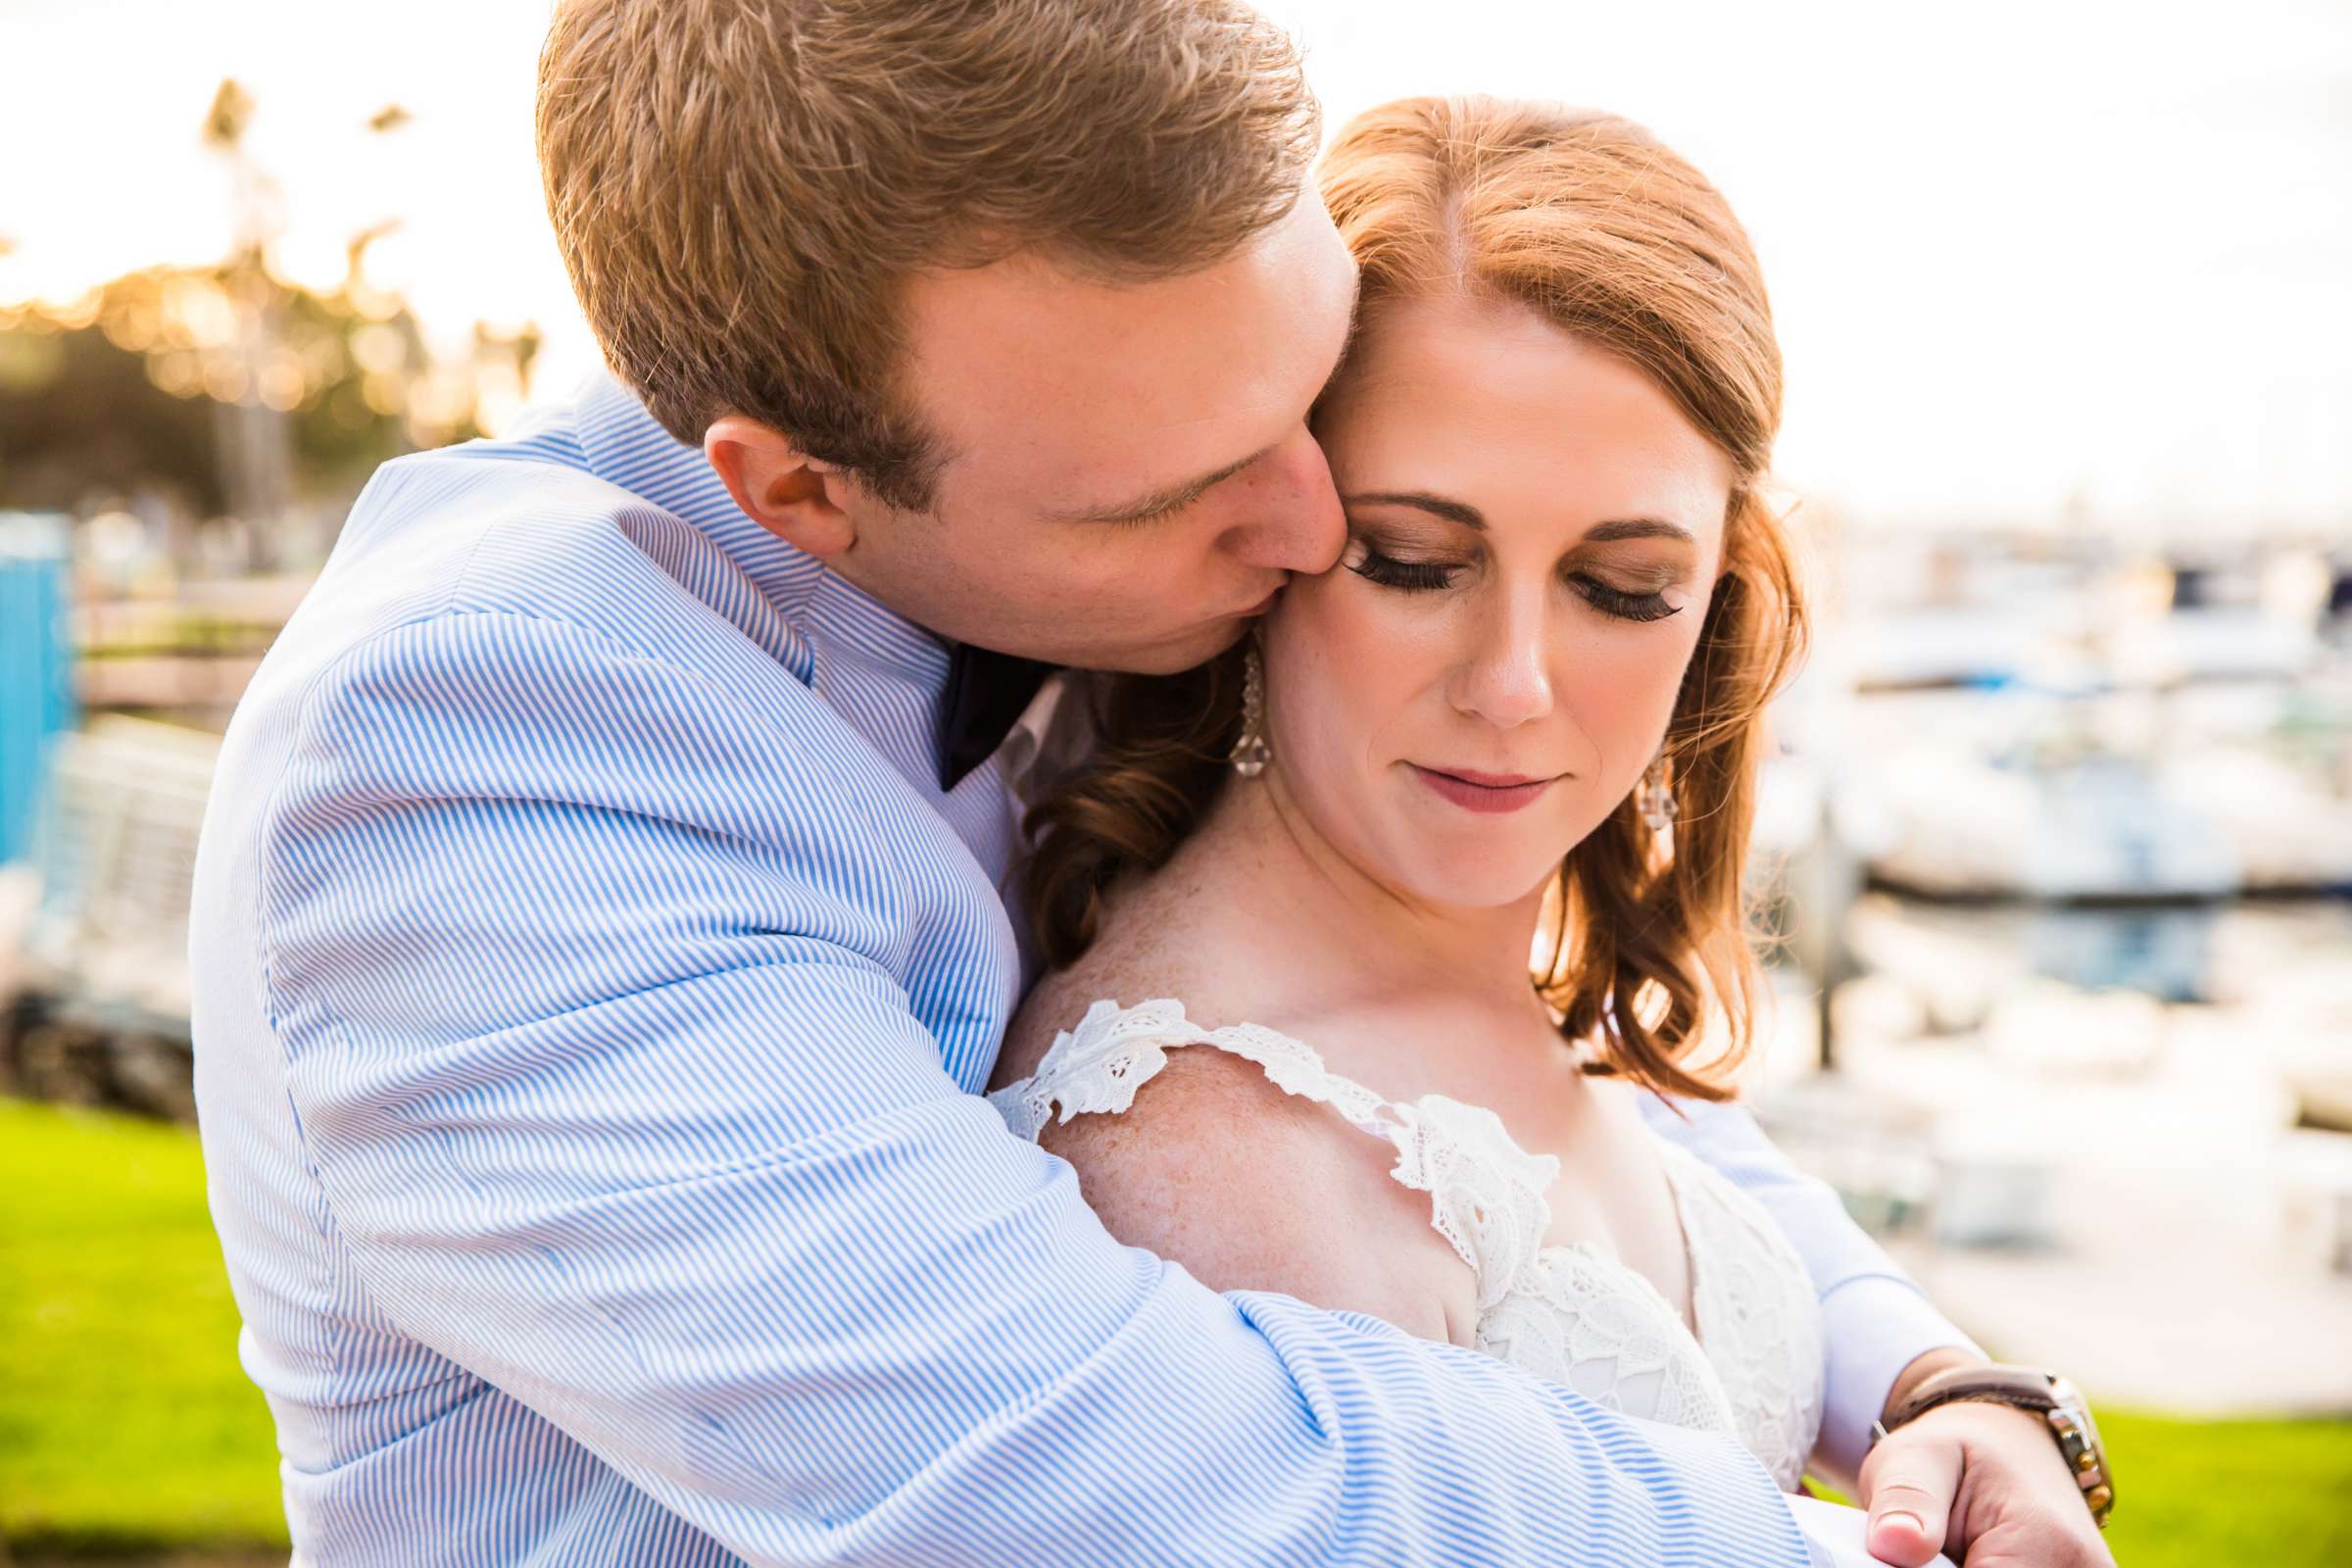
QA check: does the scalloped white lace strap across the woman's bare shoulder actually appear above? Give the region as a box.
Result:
[988,997,1559,1309]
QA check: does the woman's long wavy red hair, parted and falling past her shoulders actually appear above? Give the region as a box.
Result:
[1025,99,1806,1101]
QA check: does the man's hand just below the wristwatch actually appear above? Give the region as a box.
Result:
[1860,1401,2115,1568]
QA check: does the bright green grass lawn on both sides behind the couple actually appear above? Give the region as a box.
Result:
[0,1101,2352,1568]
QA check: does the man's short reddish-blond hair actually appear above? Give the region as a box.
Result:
[539,0,1319,511]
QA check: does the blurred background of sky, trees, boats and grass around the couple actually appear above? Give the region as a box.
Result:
[0,0,2352,1566]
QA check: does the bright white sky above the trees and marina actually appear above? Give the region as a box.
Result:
[0,0,2352,536]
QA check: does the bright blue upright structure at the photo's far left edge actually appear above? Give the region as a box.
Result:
[0,513,73,865]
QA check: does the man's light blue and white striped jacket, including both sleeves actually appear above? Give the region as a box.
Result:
[193,381,1940,1568]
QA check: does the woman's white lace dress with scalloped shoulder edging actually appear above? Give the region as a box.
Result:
[988,999,1823,1491]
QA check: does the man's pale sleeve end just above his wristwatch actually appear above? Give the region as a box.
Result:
[1642,1096,1983,1476]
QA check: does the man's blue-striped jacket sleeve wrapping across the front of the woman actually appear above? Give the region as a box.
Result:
[261,613,1806,1568]
